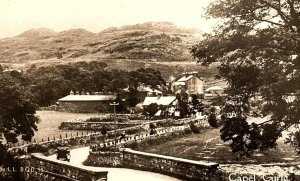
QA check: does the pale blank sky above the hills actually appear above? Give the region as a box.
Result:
[0,0,216,38]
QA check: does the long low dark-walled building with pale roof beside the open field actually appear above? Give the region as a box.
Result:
[58,95,117,112]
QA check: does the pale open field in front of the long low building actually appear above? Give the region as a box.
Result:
[34,111,99,142]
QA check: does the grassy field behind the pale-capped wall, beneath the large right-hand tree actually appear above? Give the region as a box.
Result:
[137,128,300,164]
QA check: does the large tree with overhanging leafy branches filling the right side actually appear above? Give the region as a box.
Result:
[191,0,300,155]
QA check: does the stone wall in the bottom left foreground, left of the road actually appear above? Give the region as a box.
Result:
[21,154,108,181]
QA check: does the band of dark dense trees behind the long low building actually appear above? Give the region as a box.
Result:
[24,61,165,106]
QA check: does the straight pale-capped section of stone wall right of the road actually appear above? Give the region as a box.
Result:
[123,149,219,180]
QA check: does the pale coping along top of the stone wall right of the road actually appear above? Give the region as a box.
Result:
[123,148,219,168]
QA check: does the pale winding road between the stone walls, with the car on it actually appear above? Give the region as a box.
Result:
[48,147,180,181]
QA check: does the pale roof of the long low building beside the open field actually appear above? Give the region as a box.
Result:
[58,95,117,101]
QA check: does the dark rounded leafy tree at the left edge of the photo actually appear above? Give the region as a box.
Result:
[0,74,39,166]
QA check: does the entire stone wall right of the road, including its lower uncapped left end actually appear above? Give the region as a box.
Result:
[88,148,220,181]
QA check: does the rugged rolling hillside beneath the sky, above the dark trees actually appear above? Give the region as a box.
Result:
[0,22,200,63]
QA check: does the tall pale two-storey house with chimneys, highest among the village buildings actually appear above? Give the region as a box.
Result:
[171,72,204,95]
